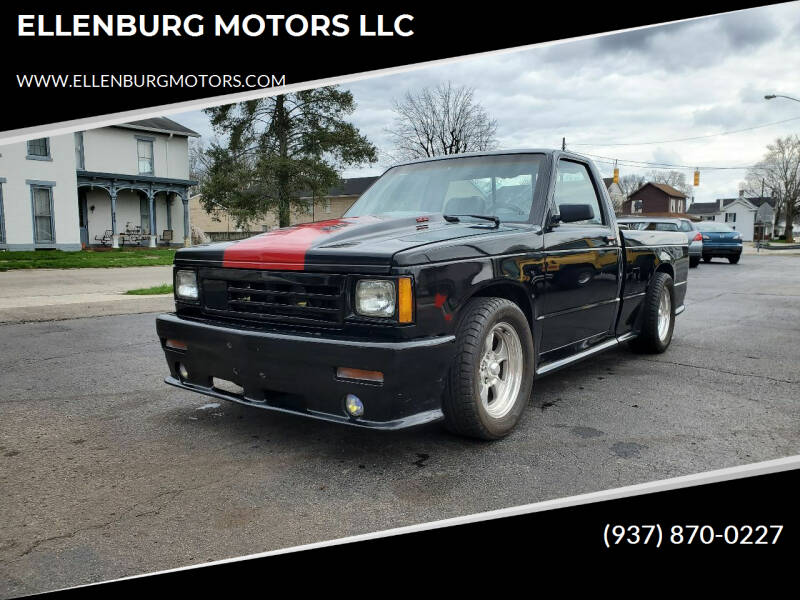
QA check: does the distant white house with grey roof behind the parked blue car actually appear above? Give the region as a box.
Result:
[687,192,775,242]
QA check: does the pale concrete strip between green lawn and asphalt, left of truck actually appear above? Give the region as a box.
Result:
[0,266,173,323]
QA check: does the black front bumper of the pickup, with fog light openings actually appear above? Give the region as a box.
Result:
[156,314,455,429]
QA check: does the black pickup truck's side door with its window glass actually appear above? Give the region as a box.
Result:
[537,158,621,354]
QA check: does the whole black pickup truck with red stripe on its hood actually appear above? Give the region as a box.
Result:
[157,150,689,439]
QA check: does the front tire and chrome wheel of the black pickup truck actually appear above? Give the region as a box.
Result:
[442,298,534,440]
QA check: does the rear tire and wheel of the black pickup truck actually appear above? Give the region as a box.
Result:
[631,272,675,354]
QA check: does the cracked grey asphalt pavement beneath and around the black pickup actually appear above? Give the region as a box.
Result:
[0,255,800,597]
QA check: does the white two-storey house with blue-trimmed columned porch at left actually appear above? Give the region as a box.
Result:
[0,118,198,250]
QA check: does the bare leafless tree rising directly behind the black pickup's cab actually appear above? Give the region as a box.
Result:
[387,82,497,160]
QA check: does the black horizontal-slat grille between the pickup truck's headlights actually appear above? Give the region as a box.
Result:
[200,269,345,326]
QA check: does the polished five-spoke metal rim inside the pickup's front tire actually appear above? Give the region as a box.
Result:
[478,322,523,419]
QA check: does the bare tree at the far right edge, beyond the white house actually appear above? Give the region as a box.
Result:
[745,135,800,242]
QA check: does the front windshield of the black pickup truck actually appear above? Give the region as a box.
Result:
[344,154,545,222]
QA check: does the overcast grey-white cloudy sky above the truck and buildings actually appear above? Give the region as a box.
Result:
[174,2,800,202]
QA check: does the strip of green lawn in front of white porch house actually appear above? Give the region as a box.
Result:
[0,248,175,271]
